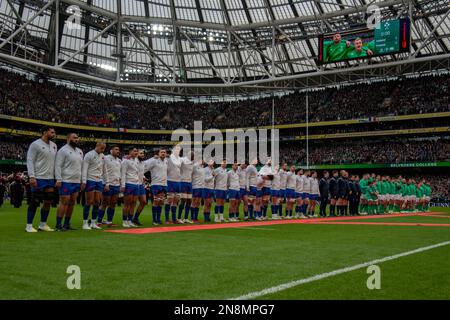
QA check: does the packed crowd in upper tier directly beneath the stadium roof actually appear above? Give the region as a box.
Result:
[0,69,450,129]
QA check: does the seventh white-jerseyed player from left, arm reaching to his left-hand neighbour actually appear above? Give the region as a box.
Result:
[144,148,167,225]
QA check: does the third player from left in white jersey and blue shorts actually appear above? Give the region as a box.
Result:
[81,142,106,230]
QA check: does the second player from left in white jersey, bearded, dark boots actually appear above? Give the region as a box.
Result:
[55,133,84,231]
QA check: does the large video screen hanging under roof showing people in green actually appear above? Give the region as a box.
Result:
[319,18,410,64]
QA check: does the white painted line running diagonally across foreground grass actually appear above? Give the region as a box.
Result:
[228,241,450,300]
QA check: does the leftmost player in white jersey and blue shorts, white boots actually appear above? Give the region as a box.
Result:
[25,127,57,232]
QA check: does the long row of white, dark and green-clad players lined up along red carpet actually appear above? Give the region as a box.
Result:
[25,127,431,232]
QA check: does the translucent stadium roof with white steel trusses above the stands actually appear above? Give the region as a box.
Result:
[0,0,450,96]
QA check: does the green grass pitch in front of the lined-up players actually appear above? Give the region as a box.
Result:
[0,204,450,299]
